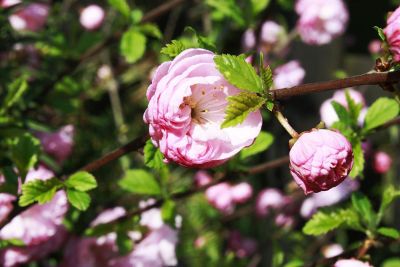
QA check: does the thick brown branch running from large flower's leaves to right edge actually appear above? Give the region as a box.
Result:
[270,71,400,100]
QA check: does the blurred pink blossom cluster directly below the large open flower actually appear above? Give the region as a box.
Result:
[198,171,253,214]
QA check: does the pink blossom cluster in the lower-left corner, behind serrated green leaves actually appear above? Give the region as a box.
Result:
[0,166,68,267]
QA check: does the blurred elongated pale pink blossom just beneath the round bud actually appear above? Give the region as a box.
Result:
[300,178,359,218]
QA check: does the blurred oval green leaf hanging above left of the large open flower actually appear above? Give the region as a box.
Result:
[120,28,147,63]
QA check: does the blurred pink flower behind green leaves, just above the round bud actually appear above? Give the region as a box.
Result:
[320,88,367,127]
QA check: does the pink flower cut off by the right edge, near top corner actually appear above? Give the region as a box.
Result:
[383,8,400,62]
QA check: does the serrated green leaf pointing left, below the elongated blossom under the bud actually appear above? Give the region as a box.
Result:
[303,209,361,235]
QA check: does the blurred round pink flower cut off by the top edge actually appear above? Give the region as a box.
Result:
[295,0,349,45]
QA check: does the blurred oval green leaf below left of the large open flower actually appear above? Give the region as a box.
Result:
[118,169,161,196]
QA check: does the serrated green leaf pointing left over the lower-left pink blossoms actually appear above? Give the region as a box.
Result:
[18,177,62,207]
